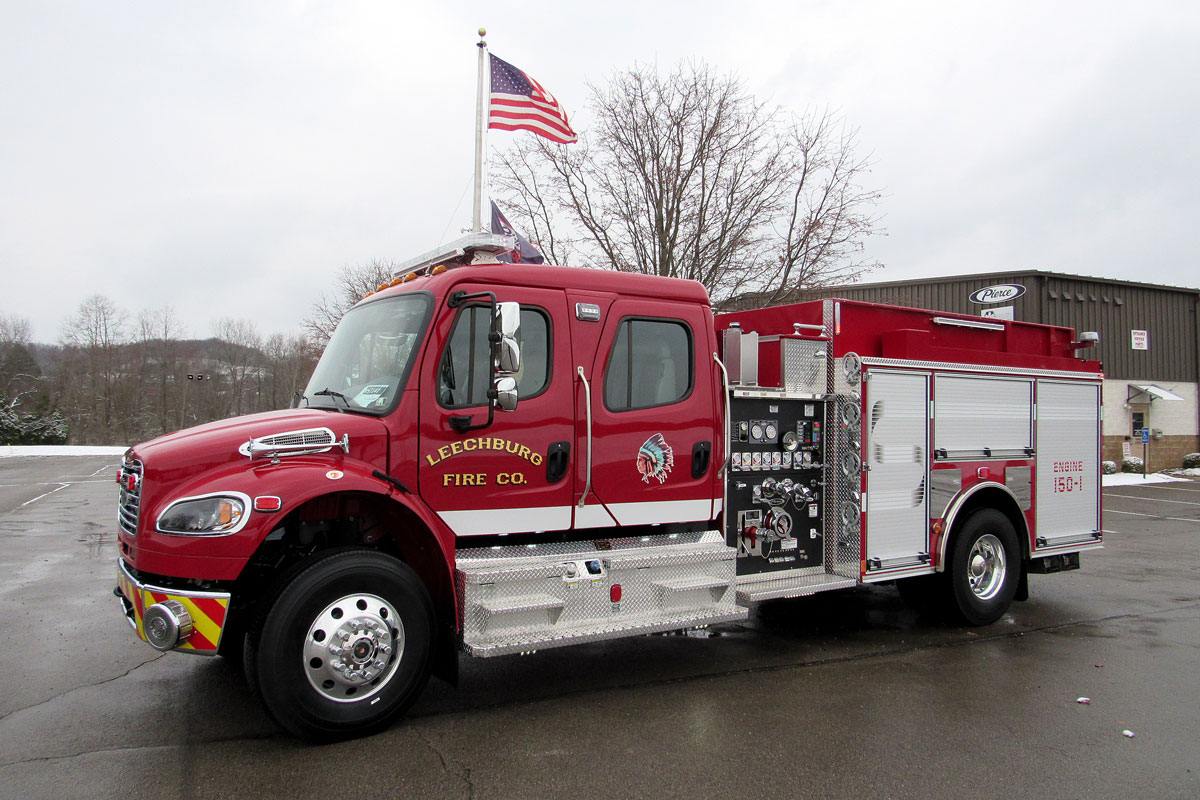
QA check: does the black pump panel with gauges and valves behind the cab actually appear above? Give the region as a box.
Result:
[725,392,826,576]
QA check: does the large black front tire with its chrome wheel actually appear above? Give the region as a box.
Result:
[246,551,434,741]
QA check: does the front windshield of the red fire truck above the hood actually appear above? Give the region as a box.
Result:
[305,294,430,414]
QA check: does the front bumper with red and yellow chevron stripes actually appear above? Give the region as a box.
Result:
[113,559,229,656]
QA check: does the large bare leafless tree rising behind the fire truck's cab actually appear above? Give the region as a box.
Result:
[494,65,878,300]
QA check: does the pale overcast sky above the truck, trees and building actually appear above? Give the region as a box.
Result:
[0,0,1200,342]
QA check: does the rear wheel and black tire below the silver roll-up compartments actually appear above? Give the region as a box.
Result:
[947,509,1021,625]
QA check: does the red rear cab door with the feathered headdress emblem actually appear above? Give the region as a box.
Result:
[571,296,720,529]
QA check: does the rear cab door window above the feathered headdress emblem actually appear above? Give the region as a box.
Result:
[604,319,692,411]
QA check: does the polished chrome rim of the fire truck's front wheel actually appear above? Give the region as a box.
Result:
[304,594,404,703]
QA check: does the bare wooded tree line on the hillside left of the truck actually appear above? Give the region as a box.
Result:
[0,295,319,445]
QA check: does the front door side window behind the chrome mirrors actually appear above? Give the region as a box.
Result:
[438,306,551,408]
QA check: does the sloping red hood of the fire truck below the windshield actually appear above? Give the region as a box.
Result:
[133,409,388,483]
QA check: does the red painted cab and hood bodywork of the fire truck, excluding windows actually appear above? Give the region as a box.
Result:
[119,264,722,581]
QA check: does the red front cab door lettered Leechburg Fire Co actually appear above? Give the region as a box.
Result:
[418,284,575,536]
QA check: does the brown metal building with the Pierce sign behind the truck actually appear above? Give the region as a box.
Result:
[758,270,1200,470]
